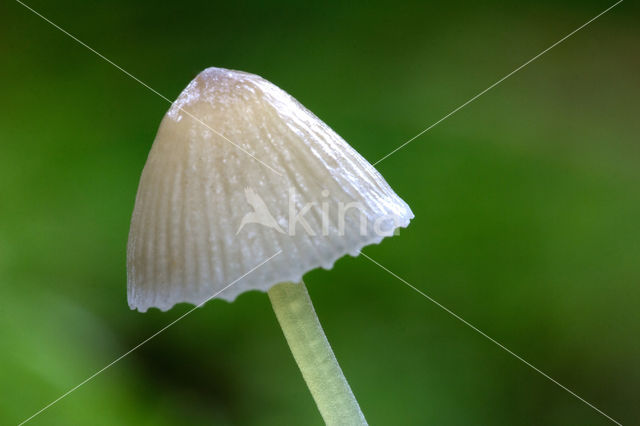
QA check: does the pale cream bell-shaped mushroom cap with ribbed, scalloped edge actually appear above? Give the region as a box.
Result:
[127,68,413,312]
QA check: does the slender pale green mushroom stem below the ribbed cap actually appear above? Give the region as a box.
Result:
[269,283,367,426]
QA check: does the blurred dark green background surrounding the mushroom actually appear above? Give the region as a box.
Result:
[0,0,640,426]
